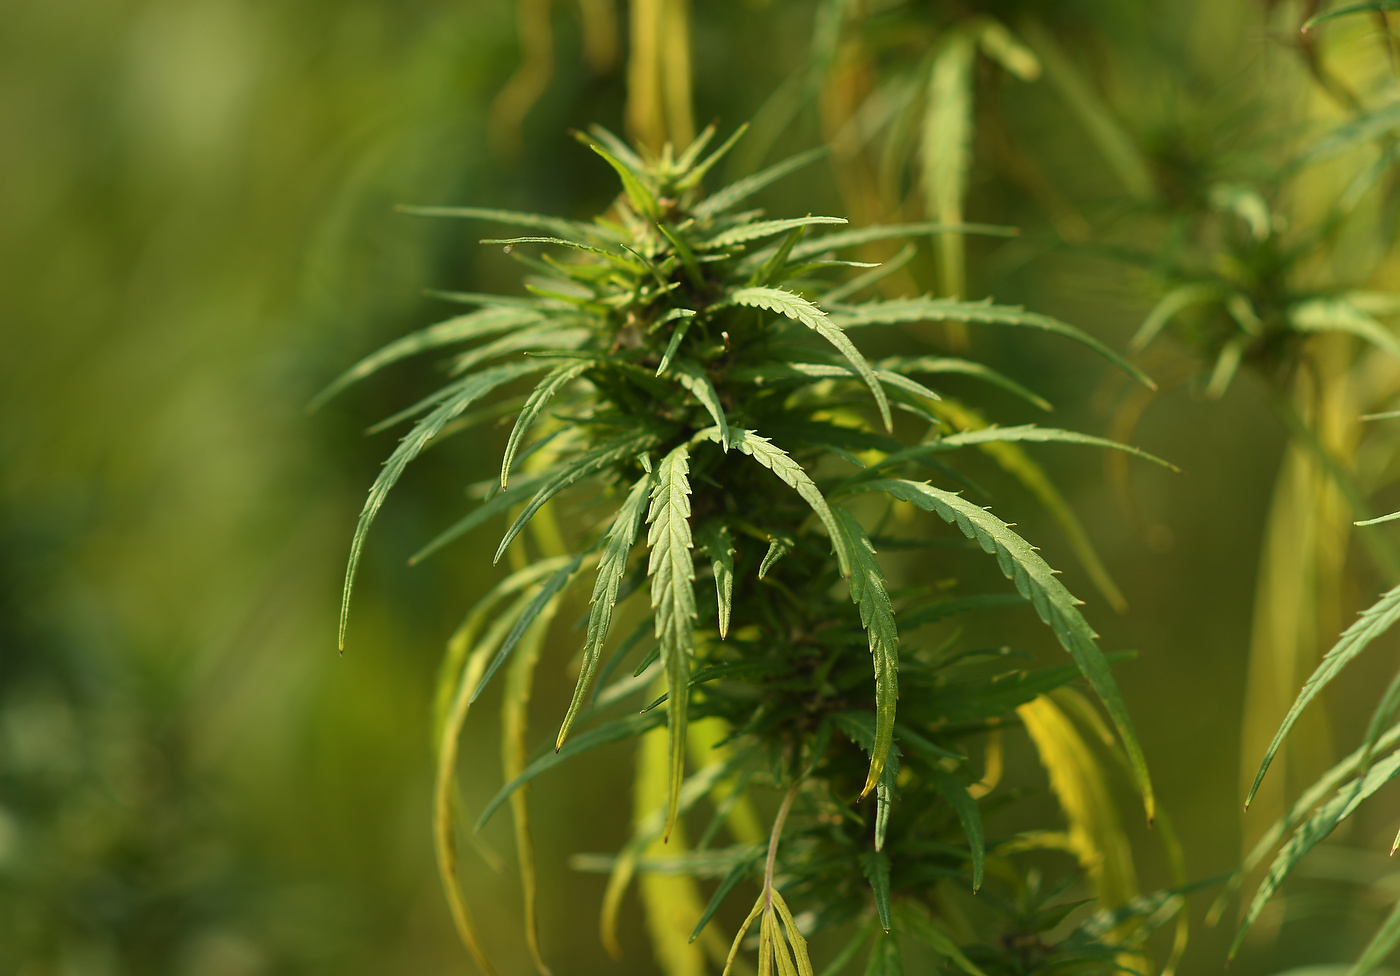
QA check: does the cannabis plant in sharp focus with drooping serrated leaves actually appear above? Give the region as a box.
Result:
[326,127,1180,975]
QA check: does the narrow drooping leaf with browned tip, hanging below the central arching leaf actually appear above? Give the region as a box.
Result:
[832,506,899,797]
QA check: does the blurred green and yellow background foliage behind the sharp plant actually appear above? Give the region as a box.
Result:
[8,0,1400,976]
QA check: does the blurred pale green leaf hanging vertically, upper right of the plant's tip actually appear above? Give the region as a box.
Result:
[921,31,976,295]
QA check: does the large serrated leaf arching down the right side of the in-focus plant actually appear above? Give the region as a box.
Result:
[853,480,1156,822]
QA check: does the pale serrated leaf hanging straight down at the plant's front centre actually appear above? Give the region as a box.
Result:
[647,444,696,837]
